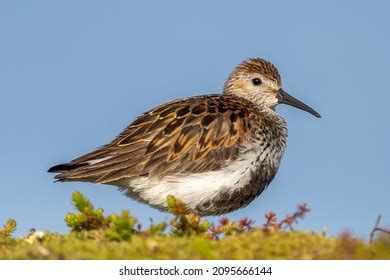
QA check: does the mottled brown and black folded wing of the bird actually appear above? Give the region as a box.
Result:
[57,95,255,183]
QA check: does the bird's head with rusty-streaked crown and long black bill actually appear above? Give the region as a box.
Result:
[224,58,321,118]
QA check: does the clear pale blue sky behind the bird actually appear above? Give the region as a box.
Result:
[0,0,390,237]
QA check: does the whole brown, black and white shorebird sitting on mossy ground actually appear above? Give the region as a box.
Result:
[48,58,321,216]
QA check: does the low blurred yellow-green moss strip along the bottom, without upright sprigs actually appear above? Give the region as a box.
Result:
[0,230,390,259]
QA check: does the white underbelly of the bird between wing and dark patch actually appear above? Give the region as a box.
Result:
[122,150,270,210]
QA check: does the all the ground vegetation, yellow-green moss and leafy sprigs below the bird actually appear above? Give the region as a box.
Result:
[0,192,390,259]
